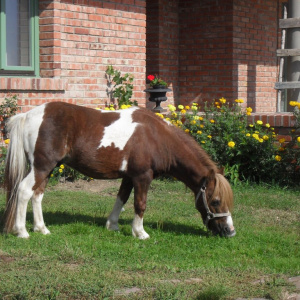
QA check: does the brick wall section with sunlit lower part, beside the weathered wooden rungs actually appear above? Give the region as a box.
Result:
[232,0,278,113]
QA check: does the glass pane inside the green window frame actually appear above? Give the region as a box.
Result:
[5,0,31,66]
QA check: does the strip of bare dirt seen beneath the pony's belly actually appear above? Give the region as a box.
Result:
[51,179,121,193]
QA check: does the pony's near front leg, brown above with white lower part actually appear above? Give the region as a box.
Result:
[132,176,152,240]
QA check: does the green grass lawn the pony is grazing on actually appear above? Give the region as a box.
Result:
[0,181,300,299]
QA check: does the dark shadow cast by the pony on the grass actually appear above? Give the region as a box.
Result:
[0,210,209,236]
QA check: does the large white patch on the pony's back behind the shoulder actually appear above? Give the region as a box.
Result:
[98,107,139,150]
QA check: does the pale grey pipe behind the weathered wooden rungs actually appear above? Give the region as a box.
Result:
[287,0,300,102]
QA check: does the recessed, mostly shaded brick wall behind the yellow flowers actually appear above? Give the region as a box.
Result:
[147,0,282,113]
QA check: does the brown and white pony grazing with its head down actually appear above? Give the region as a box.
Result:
[4,102,235,239]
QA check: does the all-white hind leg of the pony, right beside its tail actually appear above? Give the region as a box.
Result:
[12,170,35,238]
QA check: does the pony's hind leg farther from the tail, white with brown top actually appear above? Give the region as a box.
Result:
[31,179,50,234]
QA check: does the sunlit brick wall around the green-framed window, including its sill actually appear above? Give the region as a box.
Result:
[0,0,146,111]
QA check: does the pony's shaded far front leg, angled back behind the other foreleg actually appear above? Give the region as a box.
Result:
[106,177,133,230]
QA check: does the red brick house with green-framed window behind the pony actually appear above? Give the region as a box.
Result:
[0,0,296,129]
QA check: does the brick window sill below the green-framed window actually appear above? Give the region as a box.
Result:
[0,77,67,91]
